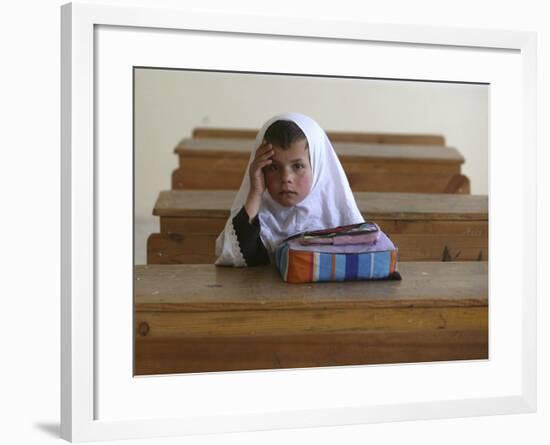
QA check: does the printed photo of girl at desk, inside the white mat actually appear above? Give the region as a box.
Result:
[133,67,489,376]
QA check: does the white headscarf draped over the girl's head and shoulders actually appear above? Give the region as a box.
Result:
[215,113,364,266]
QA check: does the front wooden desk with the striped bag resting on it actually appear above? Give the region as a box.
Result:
[134,262,488,375]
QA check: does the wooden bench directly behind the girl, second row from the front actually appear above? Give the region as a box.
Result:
[147,190,488,264]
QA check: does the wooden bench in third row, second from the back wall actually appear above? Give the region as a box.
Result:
[172,138,470,193]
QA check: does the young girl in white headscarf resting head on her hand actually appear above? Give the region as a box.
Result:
[215,113,364,267]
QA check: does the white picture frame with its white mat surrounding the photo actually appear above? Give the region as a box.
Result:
[61,3,537,441]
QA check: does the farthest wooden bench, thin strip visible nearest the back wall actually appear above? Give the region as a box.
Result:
[193,127,445,146]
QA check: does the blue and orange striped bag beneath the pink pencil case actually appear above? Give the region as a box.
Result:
[275,224,401,283]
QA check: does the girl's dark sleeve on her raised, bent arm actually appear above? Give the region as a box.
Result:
[233,206,269,266]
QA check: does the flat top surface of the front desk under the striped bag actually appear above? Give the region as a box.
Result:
[134,261,488,311]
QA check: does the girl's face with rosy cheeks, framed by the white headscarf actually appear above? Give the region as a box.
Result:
[264,139,313,207]
